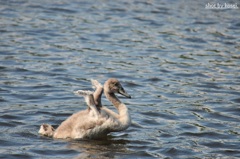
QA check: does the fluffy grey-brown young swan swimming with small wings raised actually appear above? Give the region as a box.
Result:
[39,78,131,139]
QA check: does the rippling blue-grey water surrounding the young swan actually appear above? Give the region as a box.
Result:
[0,0,240,159]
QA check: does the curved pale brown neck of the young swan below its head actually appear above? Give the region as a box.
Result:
[104,92,131,131]
